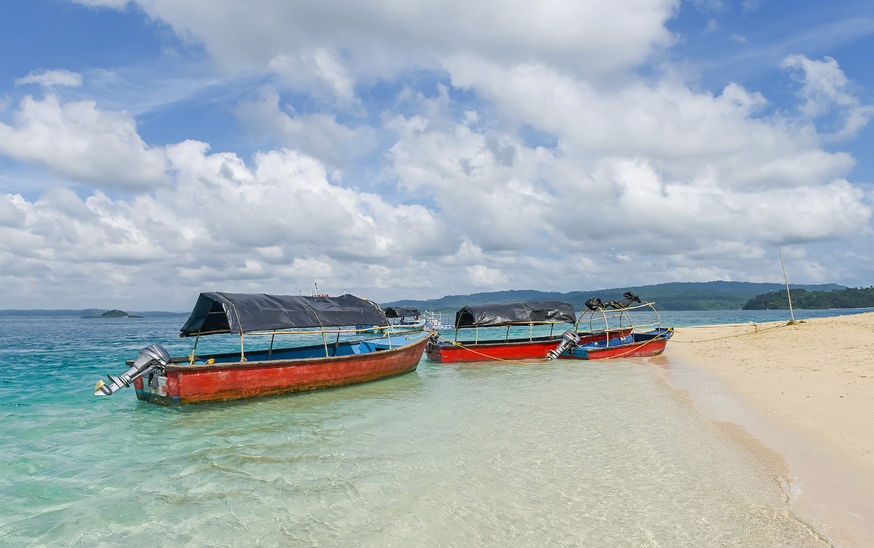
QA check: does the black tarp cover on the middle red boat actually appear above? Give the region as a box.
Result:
[455,301,577,327]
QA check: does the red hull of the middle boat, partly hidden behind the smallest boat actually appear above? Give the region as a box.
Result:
[425,328,631,363]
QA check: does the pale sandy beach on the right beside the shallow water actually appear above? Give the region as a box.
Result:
[665,312,874,546]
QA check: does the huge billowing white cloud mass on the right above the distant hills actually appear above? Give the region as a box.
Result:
[390,57,871,272]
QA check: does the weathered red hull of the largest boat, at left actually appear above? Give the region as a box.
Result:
[134,337,429,405]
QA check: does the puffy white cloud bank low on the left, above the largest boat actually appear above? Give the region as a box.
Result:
[0,141,446,307]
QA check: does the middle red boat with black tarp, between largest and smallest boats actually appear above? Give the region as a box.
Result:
[425,301,631,363]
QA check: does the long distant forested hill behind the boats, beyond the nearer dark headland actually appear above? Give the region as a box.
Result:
[383,281,845,312]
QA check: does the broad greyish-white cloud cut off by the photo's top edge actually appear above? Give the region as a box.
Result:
[75,0,678,80]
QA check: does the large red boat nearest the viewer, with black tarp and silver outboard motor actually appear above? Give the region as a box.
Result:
[95,293,431,405]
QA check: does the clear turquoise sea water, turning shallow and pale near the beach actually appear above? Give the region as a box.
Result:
[0,311,864,546]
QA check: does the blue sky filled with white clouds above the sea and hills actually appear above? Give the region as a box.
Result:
[0,0,874,311]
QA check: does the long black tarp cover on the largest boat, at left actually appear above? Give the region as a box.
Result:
[179,293,389,337]
